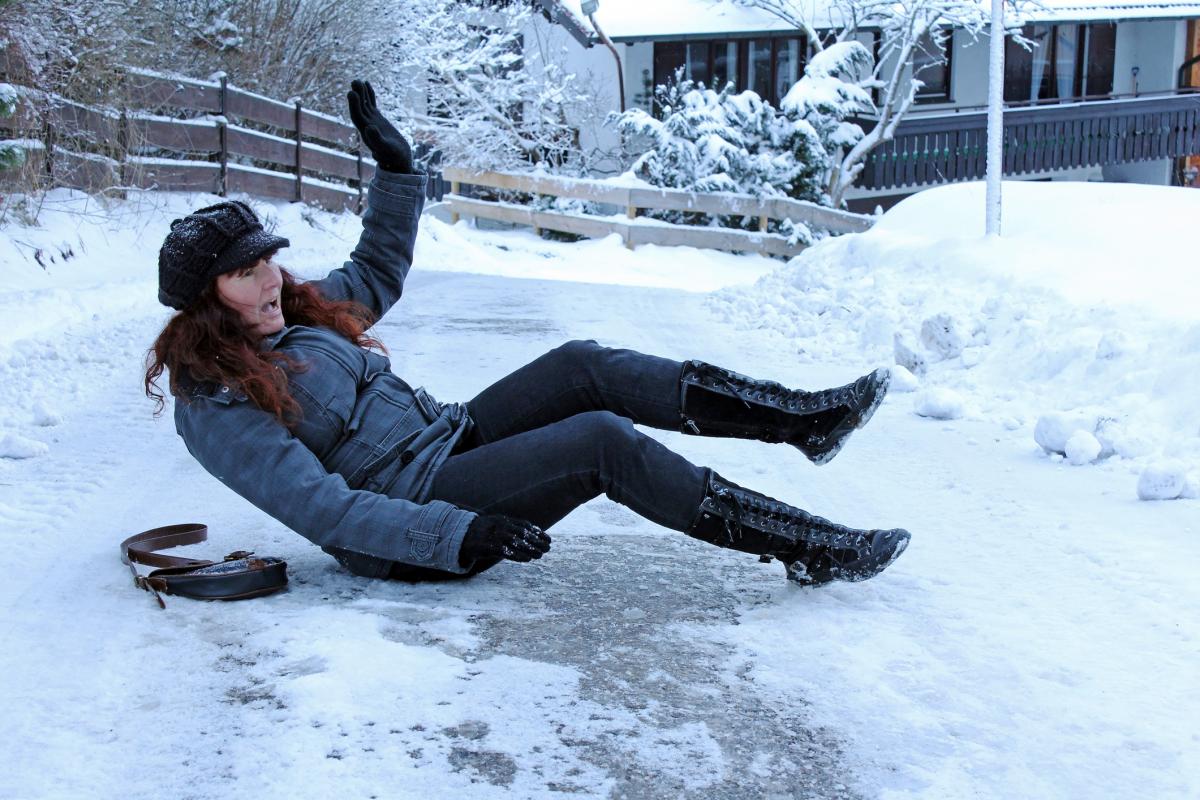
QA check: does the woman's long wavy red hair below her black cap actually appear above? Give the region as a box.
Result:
[145,269,384,425]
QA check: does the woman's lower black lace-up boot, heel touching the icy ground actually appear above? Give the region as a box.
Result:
[688,471,911,585]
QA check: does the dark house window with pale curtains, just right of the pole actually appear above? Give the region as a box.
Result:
[1004,23,1116,103]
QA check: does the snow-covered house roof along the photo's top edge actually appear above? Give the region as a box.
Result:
[559,0,1200,41]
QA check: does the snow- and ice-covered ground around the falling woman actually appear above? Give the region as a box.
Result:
[0,187,1200,800]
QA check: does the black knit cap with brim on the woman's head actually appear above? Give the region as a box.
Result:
[158,200,292,308]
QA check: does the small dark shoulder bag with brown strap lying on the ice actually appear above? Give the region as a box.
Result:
[121,523,288,608]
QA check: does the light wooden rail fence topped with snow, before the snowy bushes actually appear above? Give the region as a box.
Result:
[444,167,874,255]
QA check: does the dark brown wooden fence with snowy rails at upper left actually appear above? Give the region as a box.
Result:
[0,70,434,210]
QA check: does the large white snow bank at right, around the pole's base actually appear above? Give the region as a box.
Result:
[713,182,1200,497]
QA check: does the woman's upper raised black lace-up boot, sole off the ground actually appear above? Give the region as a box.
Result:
[679,361,892,464]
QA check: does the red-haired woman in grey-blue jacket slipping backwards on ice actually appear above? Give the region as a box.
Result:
[145,80,910,585]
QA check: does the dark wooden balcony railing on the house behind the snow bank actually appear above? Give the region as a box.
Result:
[857,94,1200,190]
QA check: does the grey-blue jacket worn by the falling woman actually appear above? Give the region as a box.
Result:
[175,170,475,577]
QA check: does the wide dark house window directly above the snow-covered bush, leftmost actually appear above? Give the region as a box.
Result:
[654,36,805,106]
